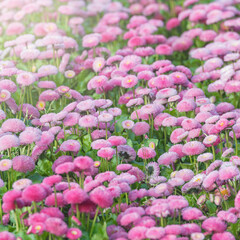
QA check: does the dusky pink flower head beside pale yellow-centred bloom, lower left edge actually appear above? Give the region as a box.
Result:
[12,155,35,173]
